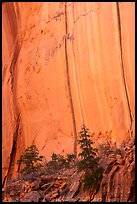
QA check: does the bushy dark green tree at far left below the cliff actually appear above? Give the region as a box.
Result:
[17,145,44,175]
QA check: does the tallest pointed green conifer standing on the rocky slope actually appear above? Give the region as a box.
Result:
[78,124,103,192]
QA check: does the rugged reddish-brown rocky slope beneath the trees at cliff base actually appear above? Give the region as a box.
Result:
[3,139,135,202]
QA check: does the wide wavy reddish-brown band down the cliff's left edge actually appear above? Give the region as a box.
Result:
[3,3,24,186]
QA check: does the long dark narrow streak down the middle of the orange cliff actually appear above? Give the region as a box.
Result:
[65,2,77,156]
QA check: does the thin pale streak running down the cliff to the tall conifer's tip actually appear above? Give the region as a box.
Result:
[72,2,85,123]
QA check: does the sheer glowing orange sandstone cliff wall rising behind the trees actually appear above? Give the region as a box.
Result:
[2,2,135,181]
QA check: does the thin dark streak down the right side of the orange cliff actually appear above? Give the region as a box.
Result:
[116,2,133,130]
